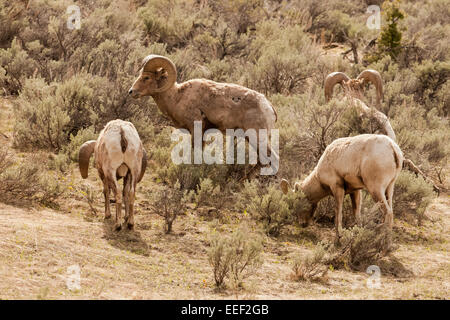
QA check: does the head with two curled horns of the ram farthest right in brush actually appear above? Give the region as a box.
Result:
[324,69,383,105]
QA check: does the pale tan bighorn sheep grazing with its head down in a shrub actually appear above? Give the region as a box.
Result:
[280,134,403,242]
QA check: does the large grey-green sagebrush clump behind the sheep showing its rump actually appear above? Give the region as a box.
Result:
[15,74,152,151]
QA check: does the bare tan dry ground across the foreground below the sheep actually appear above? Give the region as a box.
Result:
[0,98,450,299]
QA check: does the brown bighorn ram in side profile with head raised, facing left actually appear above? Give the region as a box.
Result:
[128,55,278,175]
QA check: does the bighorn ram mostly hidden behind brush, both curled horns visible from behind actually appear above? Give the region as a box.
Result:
[324,69,396,141]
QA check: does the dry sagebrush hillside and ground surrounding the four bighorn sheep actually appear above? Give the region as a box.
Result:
[0,0,450,299]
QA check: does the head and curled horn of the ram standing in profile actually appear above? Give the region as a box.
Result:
[128,54,177,98]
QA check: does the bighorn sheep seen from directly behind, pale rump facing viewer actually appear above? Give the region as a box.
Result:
[78,120,147,231]
